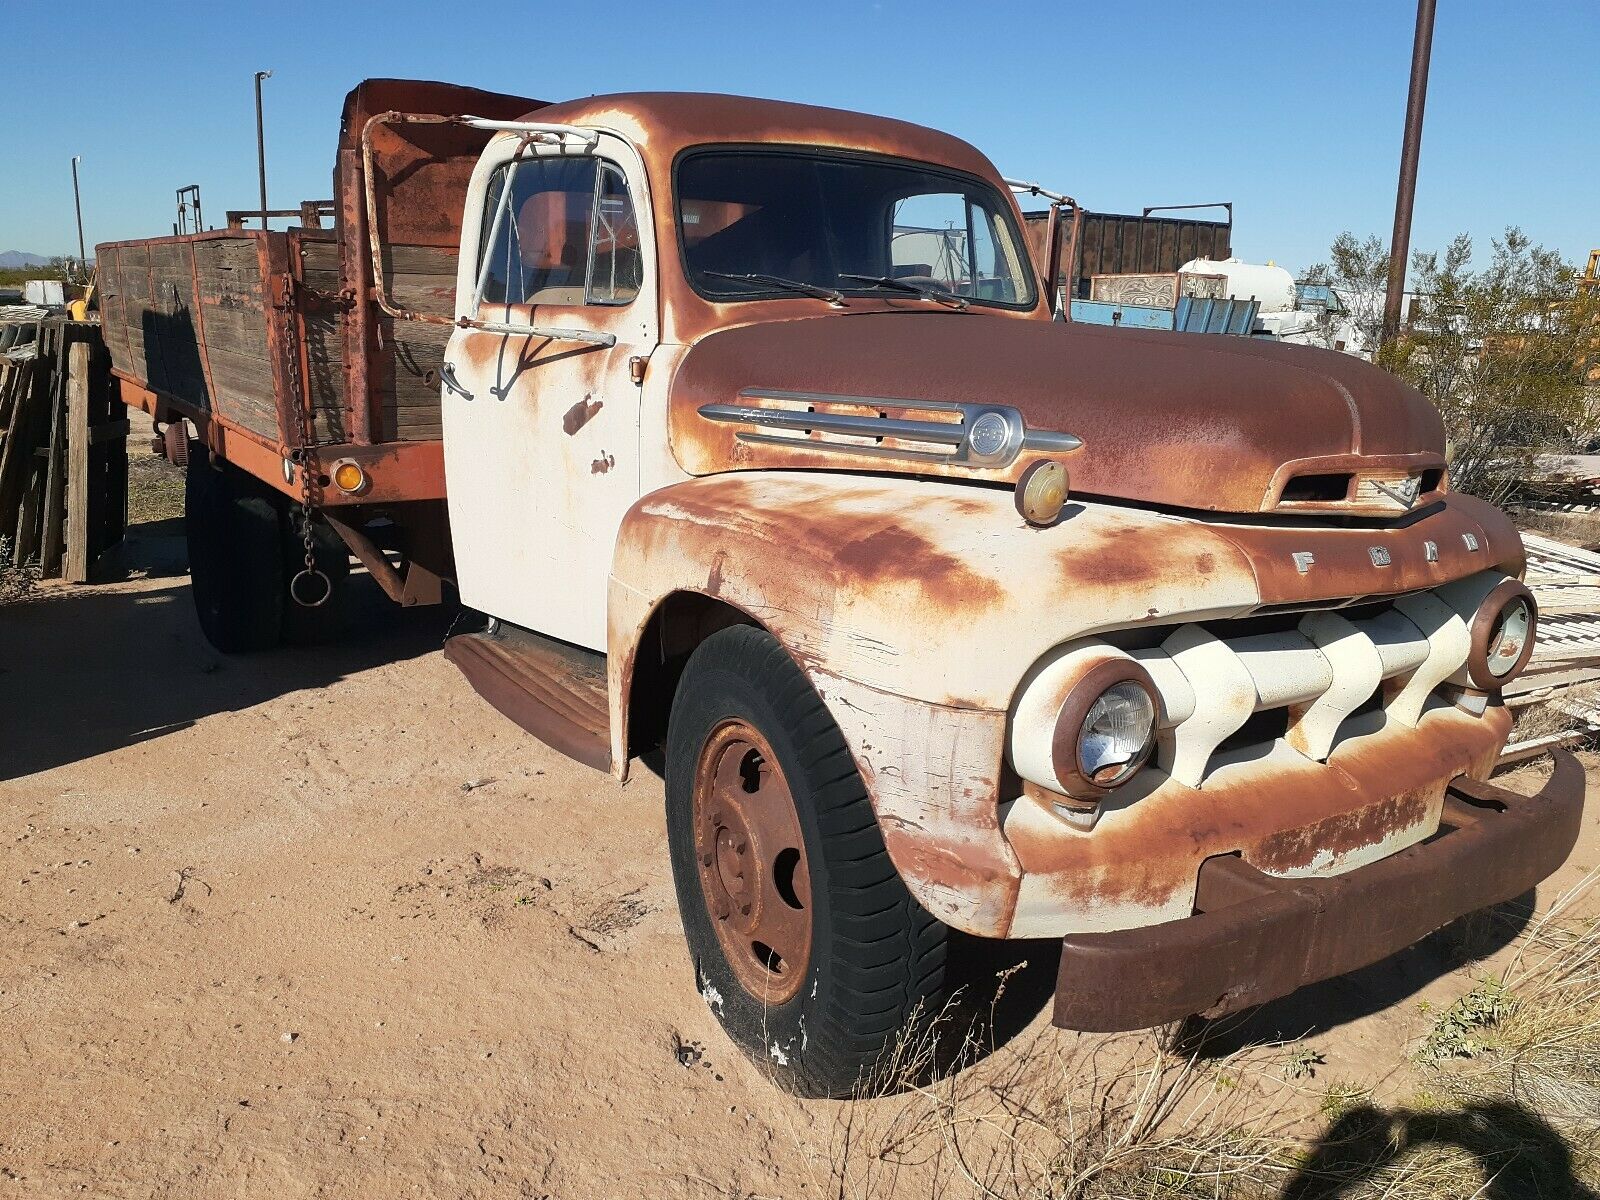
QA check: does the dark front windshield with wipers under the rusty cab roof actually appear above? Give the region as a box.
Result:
[677,149,1034,309]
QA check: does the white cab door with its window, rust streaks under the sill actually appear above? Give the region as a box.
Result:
[442,133,659,650]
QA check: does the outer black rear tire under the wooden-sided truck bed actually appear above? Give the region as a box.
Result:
[184,446,288,654]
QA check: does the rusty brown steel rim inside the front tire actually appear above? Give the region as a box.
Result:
[694,720,811,1005]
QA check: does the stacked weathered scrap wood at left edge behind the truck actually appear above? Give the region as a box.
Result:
[0,317,128,582]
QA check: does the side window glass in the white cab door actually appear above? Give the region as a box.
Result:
[478,157,643,304]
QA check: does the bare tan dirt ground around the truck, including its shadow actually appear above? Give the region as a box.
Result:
[0,502,1600,1200]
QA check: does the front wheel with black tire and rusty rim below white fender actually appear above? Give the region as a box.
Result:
[666,626,952,1096]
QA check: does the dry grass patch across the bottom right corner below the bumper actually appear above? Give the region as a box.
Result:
[819,870,1600,1200]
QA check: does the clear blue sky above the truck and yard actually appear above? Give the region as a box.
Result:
[0,0,1600,270]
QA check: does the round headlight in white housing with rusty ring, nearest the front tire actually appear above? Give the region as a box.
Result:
[1011,638,1160,800]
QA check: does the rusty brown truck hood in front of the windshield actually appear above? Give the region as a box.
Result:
[670,309,1445,514]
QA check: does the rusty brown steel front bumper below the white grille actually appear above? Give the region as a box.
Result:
[1054,750,1584,1032]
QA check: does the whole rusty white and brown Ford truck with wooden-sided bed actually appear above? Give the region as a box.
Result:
[99,80,1582,1094]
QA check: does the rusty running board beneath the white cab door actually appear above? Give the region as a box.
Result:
[445,621,611,771]
